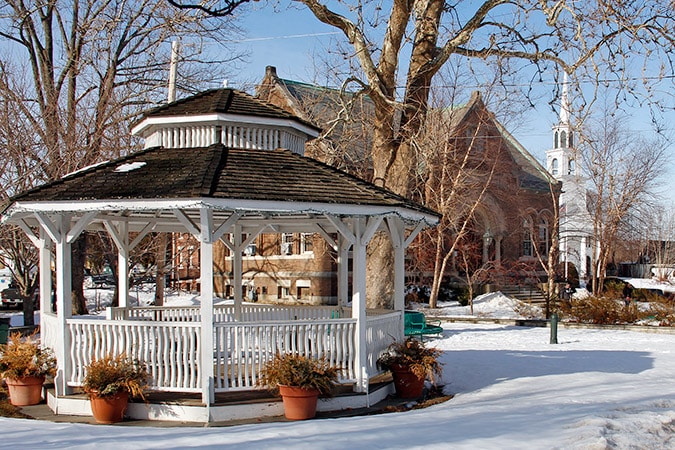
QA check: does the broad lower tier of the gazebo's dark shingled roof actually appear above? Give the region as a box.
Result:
[11,144,438,217]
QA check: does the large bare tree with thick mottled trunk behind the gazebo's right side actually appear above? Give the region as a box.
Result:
[172,0,675,307]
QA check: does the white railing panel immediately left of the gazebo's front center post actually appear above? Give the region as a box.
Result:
[67,319,201,392]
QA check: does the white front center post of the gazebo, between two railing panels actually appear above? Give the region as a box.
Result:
[199,207,216,408]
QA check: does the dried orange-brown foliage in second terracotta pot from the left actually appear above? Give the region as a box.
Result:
[82,353,150,399]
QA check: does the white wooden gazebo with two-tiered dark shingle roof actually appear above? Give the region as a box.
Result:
[2,88,438,422]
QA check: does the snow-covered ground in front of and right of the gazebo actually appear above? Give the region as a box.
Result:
[0,280,675,449]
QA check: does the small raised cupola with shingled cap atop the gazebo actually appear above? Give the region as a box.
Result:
[131,88,319,155]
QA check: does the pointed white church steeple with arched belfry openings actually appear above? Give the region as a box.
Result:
[546,73,576,180]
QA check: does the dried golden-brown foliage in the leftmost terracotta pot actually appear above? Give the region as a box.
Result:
[0,333,56,379]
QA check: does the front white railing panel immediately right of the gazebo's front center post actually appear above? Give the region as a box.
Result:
[215,319,356,392]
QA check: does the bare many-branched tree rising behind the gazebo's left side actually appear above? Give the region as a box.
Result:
[0,0,242,313]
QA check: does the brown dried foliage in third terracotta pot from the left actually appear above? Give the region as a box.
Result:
[259,353,340,397]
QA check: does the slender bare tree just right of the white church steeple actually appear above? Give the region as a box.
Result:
[579,113,666,295]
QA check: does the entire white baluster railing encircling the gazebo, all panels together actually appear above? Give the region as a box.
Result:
[65,305,403,392]
